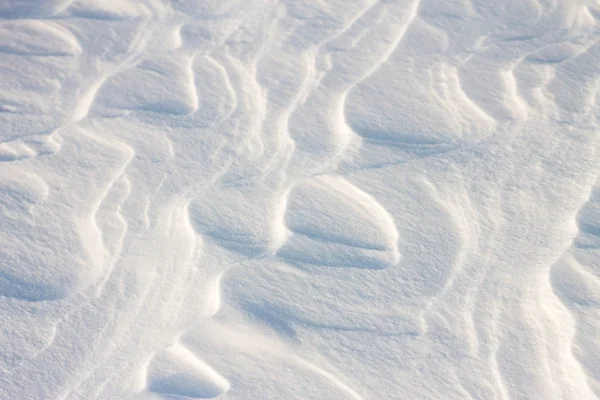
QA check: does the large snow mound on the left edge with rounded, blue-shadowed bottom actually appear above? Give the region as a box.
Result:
[0,127,132,301]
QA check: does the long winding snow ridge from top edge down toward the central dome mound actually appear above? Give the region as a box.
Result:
[290,1,419,173]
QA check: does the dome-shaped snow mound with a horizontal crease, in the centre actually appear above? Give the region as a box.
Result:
[277,176,400,269]
